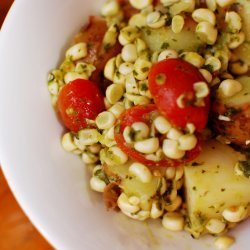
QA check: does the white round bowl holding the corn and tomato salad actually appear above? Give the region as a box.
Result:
[0,0,250,250]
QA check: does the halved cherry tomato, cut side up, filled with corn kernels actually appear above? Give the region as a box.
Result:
[115,104,201,167]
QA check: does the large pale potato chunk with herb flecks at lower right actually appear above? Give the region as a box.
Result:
[185,141,250,237]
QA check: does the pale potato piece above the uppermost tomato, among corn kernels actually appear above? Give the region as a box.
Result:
[142,27,203,52]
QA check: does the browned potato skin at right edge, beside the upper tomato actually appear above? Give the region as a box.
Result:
[211,100,250,148]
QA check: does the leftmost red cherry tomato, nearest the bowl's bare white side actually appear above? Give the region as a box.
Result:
[57,79,105,132]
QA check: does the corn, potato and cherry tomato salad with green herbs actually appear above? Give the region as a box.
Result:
[48,0,250,249]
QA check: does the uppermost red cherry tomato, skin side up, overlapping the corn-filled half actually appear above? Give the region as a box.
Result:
[148,59,210,131]
